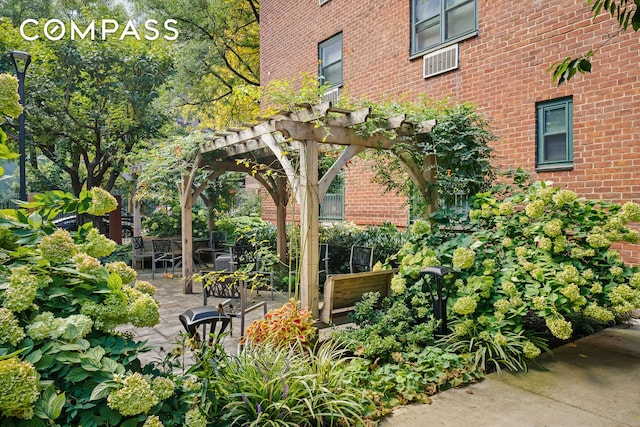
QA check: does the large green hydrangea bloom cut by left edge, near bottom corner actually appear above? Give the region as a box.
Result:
[0,357,40,420]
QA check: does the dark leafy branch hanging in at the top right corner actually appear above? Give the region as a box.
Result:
[549,0,640,86]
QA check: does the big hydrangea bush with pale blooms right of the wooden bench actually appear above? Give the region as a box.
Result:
[345,177,640,384]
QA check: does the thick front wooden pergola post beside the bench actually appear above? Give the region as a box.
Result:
[298,141,319,319]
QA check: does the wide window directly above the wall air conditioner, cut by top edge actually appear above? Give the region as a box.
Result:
[411,0,477,54]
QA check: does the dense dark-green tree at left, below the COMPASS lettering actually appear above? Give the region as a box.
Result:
[0,16,172,195]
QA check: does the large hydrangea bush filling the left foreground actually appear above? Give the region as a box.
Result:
[0,189,197,426]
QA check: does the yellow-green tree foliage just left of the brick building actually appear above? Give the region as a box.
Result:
[141,0,260,128]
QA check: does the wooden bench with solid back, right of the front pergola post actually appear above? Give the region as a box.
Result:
[320,268,398,323]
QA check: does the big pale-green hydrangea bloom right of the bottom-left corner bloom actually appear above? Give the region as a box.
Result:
[107,372,158,416]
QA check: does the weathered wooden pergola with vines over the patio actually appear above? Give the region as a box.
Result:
[180,102,435,318]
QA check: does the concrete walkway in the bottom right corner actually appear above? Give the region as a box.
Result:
[380,319,640,427]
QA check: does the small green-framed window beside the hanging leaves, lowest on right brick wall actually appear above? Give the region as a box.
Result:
[536,98,573,170]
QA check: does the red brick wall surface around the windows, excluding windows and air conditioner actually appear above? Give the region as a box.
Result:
[260,0,640,260]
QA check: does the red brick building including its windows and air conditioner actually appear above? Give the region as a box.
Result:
[260,0,640,237]
